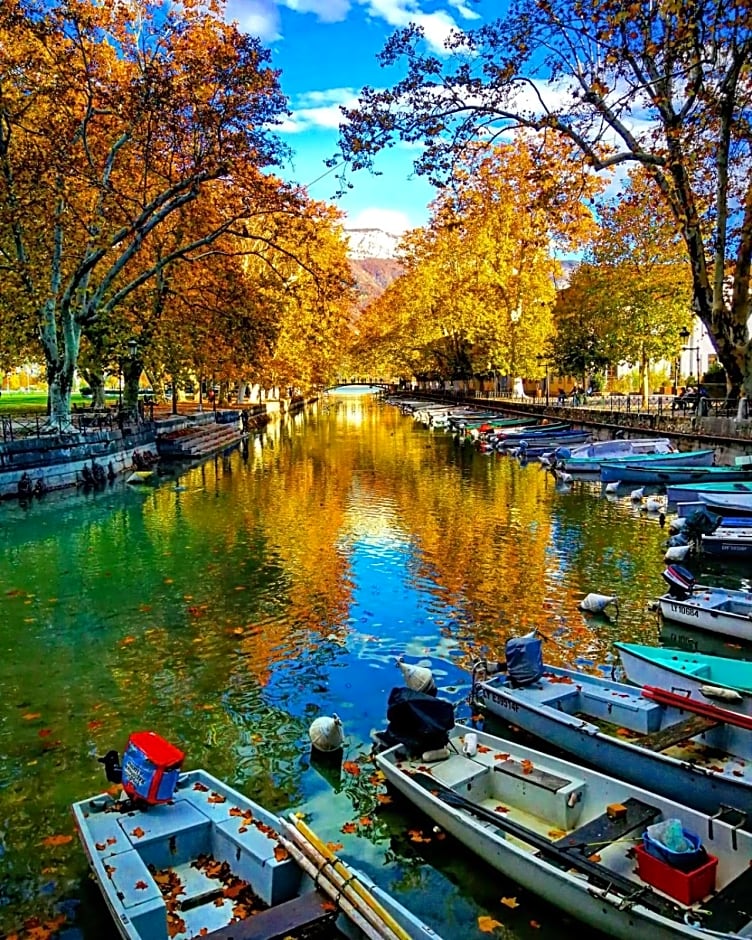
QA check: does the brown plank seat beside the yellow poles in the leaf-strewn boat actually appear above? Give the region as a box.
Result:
[207,891,339,940]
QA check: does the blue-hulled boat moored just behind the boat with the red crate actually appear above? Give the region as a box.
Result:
[471,662,752,825]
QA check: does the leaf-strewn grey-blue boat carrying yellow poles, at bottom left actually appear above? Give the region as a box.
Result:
[73,770,438,940]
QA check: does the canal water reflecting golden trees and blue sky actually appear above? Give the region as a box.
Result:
[0,398,745,940]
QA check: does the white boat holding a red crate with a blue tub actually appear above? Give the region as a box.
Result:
[375,725,752,940]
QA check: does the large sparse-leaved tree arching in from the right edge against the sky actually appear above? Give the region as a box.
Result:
[341,0,752,396]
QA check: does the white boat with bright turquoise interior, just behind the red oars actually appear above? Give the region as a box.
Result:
[614,643,752,715]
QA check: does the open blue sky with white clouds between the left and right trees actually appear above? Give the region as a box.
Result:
[227,0,488,234]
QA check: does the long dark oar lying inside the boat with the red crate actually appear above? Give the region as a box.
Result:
[410,772,684,921]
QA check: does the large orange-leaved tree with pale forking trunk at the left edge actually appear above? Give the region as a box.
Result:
[0,0,296,425]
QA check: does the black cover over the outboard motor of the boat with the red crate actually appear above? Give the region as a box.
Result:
[379,686,454,754]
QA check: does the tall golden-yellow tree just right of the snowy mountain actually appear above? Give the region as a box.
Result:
[354,133,600,378]
